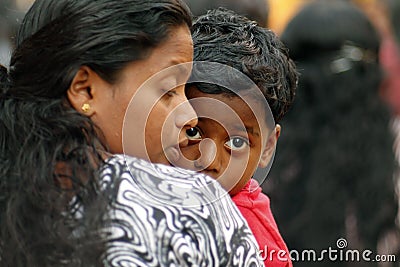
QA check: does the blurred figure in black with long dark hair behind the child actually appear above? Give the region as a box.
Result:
[263,0,397,267]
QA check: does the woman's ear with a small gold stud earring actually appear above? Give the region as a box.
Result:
[67,66,97,117]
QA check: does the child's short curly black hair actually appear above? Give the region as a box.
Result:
[192,8,298,122]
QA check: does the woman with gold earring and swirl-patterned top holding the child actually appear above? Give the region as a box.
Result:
[0,0,259,266]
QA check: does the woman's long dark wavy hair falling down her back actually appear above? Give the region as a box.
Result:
[0,0,191,267]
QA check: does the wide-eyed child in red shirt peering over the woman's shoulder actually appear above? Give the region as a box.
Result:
[178,8,298,266]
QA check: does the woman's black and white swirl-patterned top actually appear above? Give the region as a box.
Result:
[101,155,263,267]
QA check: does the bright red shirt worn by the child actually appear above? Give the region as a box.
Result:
[232,179,293,267]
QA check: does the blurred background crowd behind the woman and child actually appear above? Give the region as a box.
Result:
[0,0,400,267]
